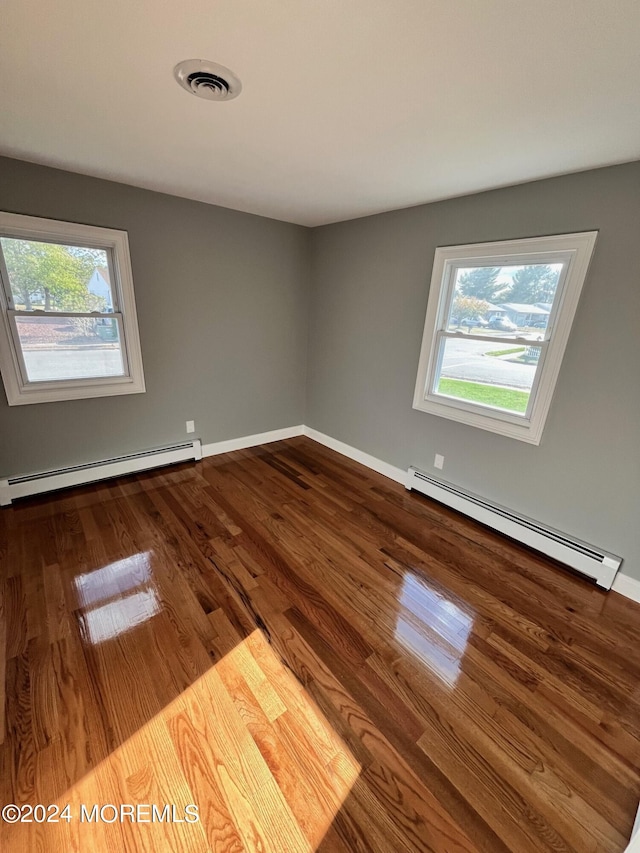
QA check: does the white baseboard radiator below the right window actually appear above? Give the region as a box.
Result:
[406,468,622,589]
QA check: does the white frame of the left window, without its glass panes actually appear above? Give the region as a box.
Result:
[0,212,145,406]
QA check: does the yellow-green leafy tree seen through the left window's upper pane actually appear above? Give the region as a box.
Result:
[2,237,95,311]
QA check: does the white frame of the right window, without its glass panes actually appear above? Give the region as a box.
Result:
[413,231,598,444]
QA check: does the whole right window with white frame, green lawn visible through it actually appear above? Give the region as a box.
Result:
[413,231,597,444]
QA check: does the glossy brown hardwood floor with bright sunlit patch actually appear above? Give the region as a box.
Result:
[0,438,640,853]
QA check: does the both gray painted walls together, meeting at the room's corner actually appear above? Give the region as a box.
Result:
[0,158,640,579]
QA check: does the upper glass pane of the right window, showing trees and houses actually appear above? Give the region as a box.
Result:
[446,263,562,340]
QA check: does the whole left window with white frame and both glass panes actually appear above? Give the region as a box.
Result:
[0,213,145,406]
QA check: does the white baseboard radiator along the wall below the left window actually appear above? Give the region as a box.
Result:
[0,439,202,506]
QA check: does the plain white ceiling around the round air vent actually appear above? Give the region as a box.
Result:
[0,0,640,225]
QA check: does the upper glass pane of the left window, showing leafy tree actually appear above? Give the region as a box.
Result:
[0,237,114,313]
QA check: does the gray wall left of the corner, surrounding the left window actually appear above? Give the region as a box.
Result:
[0,158,309,476]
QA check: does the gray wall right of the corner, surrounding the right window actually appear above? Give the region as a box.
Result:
[306,163,640,579]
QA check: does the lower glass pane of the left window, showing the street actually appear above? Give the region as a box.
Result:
[16,316,124,382]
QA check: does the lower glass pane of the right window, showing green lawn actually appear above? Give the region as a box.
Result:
[434,337,541,415]
